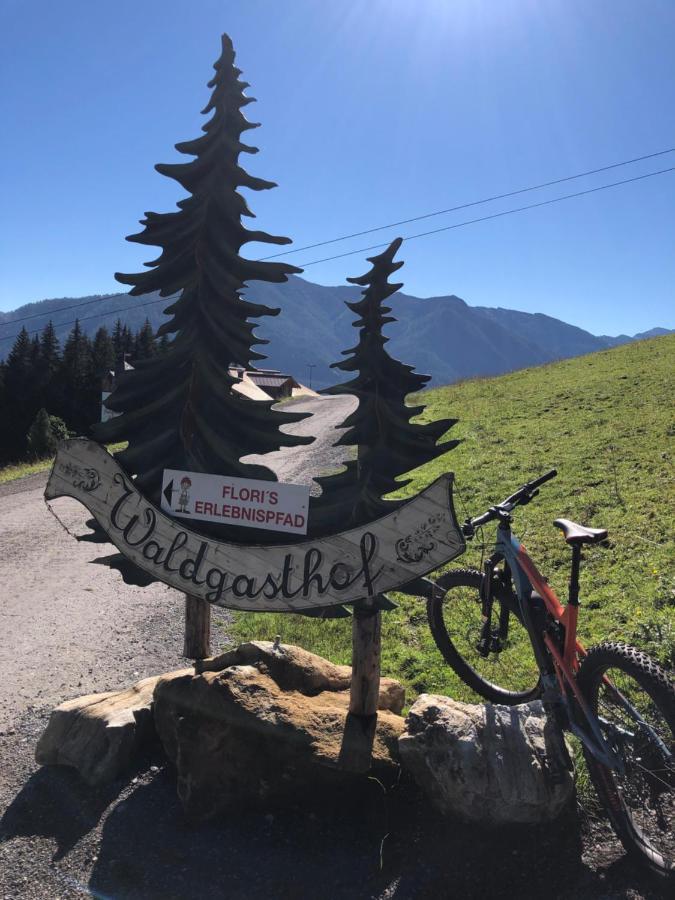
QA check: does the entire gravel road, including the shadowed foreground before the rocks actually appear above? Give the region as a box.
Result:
[0,398,660,900]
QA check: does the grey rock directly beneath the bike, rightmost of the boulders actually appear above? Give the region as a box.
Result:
[399,694,573,825]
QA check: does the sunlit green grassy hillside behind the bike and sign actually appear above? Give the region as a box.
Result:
[228,335,675,700]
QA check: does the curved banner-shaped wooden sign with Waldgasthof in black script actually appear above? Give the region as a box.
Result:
[45,439,465,612]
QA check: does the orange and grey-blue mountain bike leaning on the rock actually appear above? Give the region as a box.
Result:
[427,469,675,880]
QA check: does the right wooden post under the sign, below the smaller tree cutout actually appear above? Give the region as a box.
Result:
[349,602,382,716]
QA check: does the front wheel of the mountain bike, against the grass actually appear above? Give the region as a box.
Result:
[427,569,541,706]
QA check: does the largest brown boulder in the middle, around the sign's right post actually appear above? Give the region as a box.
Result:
[154,641,404,819]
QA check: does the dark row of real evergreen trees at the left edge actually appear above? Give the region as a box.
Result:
[0,319,169,464]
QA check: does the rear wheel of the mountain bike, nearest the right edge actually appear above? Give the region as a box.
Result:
[578,642,675,882]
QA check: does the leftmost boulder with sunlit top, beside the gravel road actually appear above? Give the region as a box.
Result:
[35,669,191,785]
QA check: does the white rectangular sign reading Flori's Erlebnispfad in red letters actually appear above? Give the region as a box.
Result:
[162,469,309,534]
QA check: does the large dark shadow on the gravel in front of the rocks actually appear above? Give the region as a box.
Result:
[89,772,602,900]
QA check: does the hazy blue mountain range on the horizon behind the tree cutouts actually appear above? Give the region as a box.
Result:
[0,276,669,387]
